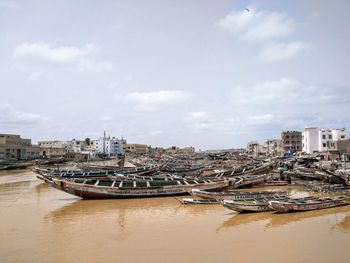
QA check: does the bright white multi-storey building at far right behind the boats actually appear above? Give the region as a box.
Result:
[302,128,349,153]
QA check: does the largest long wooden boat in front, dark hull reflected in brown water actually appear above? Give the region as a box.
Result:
[52,179,230,199]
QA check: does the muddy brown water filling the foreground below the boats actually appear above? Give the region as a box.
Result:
[0,171,350,262]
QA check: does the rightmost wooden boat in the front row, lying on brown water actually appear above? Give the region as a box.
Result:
[269,196,350,213]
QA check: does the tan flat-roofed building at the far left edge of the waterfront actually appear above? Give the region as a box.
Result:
[0,134,40,159]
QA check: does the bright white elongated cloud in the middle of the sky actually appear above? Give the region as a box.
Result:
[125,90,188,111]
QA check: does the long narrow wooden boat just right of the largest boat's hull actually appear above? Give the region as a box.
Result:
[191,189,287,200]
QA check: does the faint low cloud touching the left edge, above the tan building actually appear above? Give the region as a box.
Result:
[0,103,48,126]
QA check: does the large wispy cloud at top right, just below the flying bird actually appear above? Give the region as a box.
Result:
[215,8,295,41]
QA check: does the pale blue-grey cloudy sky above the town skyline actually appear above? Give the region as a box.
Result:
[0,0,350,150]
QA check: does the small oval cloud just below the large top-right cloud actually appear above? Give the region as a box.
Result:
[258,41,307,62]
